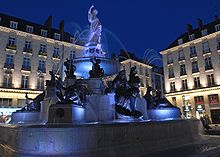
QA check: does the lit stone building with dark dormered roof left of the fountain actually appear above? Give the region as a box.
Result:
[0,14,83,112]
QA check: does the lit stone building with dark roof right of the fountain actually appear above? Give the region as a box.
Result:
[161,16,220,123]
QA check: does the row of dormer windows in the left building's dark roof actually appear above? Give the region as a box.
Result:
[7,21,73,43]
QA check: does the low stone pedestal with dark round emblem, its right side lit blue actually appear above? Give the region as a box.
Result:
[48,104,85,124]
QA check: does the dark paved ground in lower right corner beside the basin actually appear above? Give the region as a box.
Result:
[140,135,220,157]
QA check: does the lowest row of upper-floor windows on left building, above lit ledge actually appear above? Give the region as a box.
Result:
[2,72,44,90]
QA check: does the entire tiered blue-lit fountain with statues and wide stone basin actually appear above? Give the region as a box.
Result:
[0,6,203,157]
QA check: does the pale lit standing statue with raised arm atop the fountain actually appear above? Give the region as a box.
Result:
[88,5,102,46]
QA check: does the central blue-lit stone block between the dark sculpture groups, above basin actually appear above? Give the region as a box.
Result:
[86,94,115,122]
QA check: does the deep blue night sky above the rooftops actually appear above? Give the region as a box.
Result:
[0,0,220,65]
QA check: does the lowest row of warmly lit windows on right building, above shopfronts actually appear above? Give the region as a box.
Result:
[170,74,215,92]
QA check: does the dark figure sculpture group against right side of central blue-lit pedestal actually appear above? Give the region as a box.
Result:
[106,68,142,118]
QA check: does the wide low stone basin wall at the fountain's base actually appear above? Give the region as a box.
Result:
[0,120,202,157]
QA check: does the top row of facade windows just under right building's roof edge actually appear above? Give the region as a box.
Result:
[167,38,220,64]
